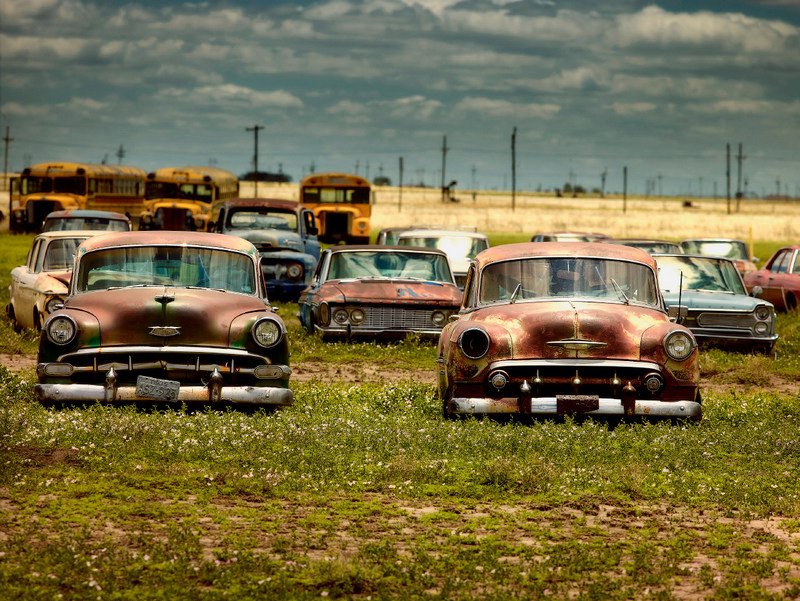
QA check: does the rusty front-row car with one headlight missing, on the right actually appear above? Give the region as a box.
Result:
[437,242,702,420]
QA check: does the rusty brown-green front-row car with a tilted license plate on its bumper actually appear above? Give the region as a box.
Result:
[35,231,293,408]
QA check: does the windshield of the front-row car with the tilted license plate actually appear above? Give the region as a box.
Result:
[75,246,256,294]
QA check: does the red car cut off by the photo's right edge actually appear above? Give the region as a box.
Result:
[744,244,800,311]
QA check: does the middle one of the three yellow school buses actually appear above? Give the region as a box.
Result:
[139,167,239,231]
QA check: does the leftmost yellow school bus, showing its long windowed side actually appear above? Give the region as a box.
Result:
[10,162,145,232]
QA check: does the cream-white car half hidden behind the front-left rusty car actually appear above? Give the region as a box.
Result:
[6,230,106,332]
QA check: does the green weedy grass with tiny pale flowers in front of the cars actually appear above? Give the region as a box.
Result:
[0,370,800,599]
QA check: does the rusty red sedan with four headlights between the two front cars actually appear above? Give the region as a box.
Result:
[298,245,461,339]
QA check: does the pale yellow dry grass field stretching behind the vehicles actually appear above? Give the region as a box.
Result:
[241,182,800,242]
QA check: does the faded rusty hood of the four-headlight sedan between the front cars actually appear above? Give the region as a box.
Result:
[324,279,461,306]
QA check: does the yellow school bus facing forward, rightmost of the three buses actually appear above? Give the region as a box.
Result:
[300,173,372,244]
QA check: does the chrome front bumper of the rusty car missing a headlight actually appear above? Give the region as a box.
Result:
[447,397,703,421]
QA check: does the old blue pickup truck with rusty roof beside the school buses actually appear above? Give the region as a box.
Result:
[212,198,320,301]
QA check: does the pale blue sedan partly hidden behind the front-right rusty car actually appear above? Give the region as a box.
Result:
[653,254,778,354]
